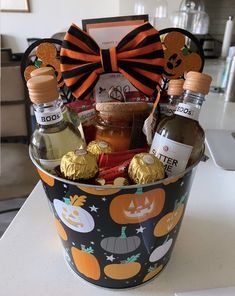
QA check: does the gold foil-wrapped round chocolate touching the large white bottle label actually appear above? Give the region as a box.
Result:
[128,153,165,184]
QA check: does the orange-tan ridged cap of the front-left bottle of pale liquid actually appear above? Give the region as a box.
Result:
[27,75,59,104]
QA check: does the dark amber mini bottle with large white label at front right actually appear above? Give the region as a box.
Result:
[150,71,212,176]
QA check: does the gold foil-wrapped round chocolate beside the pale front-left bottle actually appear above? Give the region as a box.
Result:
[60,149,98,180]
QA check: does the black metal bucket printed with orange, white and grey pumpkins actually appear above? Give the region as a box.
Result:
[30,148,200,289]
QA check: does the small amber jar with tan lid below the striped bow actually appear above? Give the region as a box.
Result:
[95,102,147,151]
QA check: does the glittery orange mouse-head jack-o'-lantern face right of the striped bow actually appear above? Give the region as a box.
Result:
[163,31,202,79]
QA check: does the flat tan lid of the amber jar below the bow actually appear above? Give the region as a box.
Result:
[96,102,148,113]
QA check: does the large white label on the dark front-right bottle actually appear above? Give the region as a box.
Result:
[150,133,193,176]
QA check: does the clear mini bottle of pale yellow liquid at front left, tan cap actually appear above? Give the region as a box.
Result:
[27,75,86,173]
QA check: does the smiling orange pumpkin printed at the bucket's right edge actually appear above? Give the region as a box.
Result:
[154,204,184,237]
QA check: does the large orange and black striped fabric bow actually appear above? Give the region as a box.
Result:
[60,23,164,99]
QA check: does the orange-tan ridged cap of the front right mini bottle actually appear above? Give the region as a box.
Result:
[183,71,212,95]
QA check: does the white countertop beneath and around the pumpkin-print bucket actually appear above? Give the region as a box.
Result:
[0,94,235,296]
